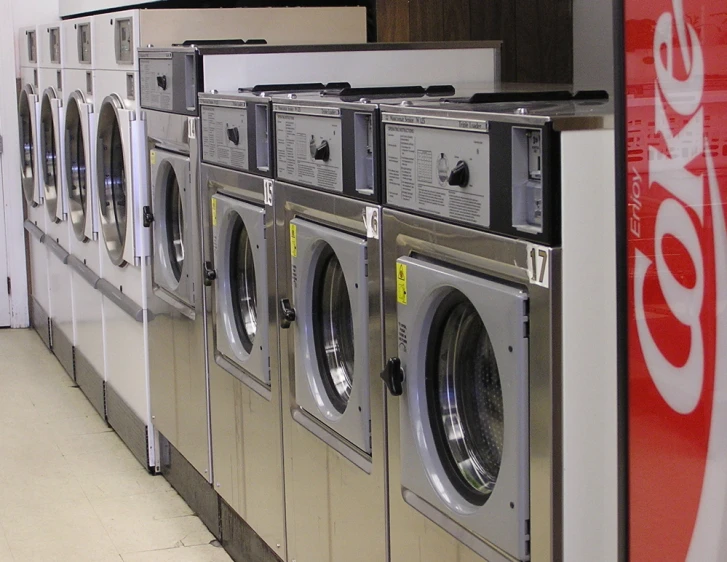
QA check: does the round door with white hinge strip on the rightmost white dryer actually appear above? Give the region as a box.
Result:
[96,96,134,266]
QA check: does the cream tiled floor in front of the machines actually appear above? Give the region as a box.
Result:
[0,330,230,562]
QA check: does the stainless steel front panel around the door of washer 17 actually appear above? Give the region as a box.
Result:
[383,210,562,562]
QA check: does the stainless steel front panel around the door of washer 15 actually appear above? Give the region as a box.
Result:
[200,164,290,560]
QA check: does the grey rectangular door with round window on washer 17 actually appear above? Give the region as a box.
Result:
[397,258,530,560]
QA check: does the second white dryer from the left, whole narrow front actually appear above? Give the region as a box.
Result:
[38,22,75,378]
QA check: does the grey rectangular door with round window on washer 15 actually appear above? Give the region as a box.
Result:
[211,194,274,388]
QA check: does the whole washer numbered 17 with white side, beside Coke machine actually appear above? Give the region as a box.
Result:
[381,100,618,562]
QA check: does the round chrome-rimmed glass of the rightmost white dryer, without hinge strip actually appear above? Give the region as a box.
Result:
[96,102,127,265]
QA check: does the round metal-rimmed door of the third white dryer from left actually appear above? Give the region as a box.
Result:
[65,92,93,242]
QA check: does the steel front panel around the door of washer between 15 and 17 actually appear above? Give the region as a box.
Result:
[274,182,390,562]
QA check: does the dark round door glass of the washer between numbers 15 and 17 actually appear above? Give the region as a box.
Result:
[312,245,354,414]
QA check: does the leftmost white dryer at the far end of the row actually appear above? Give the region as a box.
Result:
[18,27,50,348]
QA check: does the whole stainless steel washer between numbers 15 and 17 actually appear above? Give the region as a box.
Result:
[270,81,486,562]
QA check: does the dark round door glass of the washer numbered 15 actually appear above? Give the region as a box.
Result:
[229,215,258,353]
